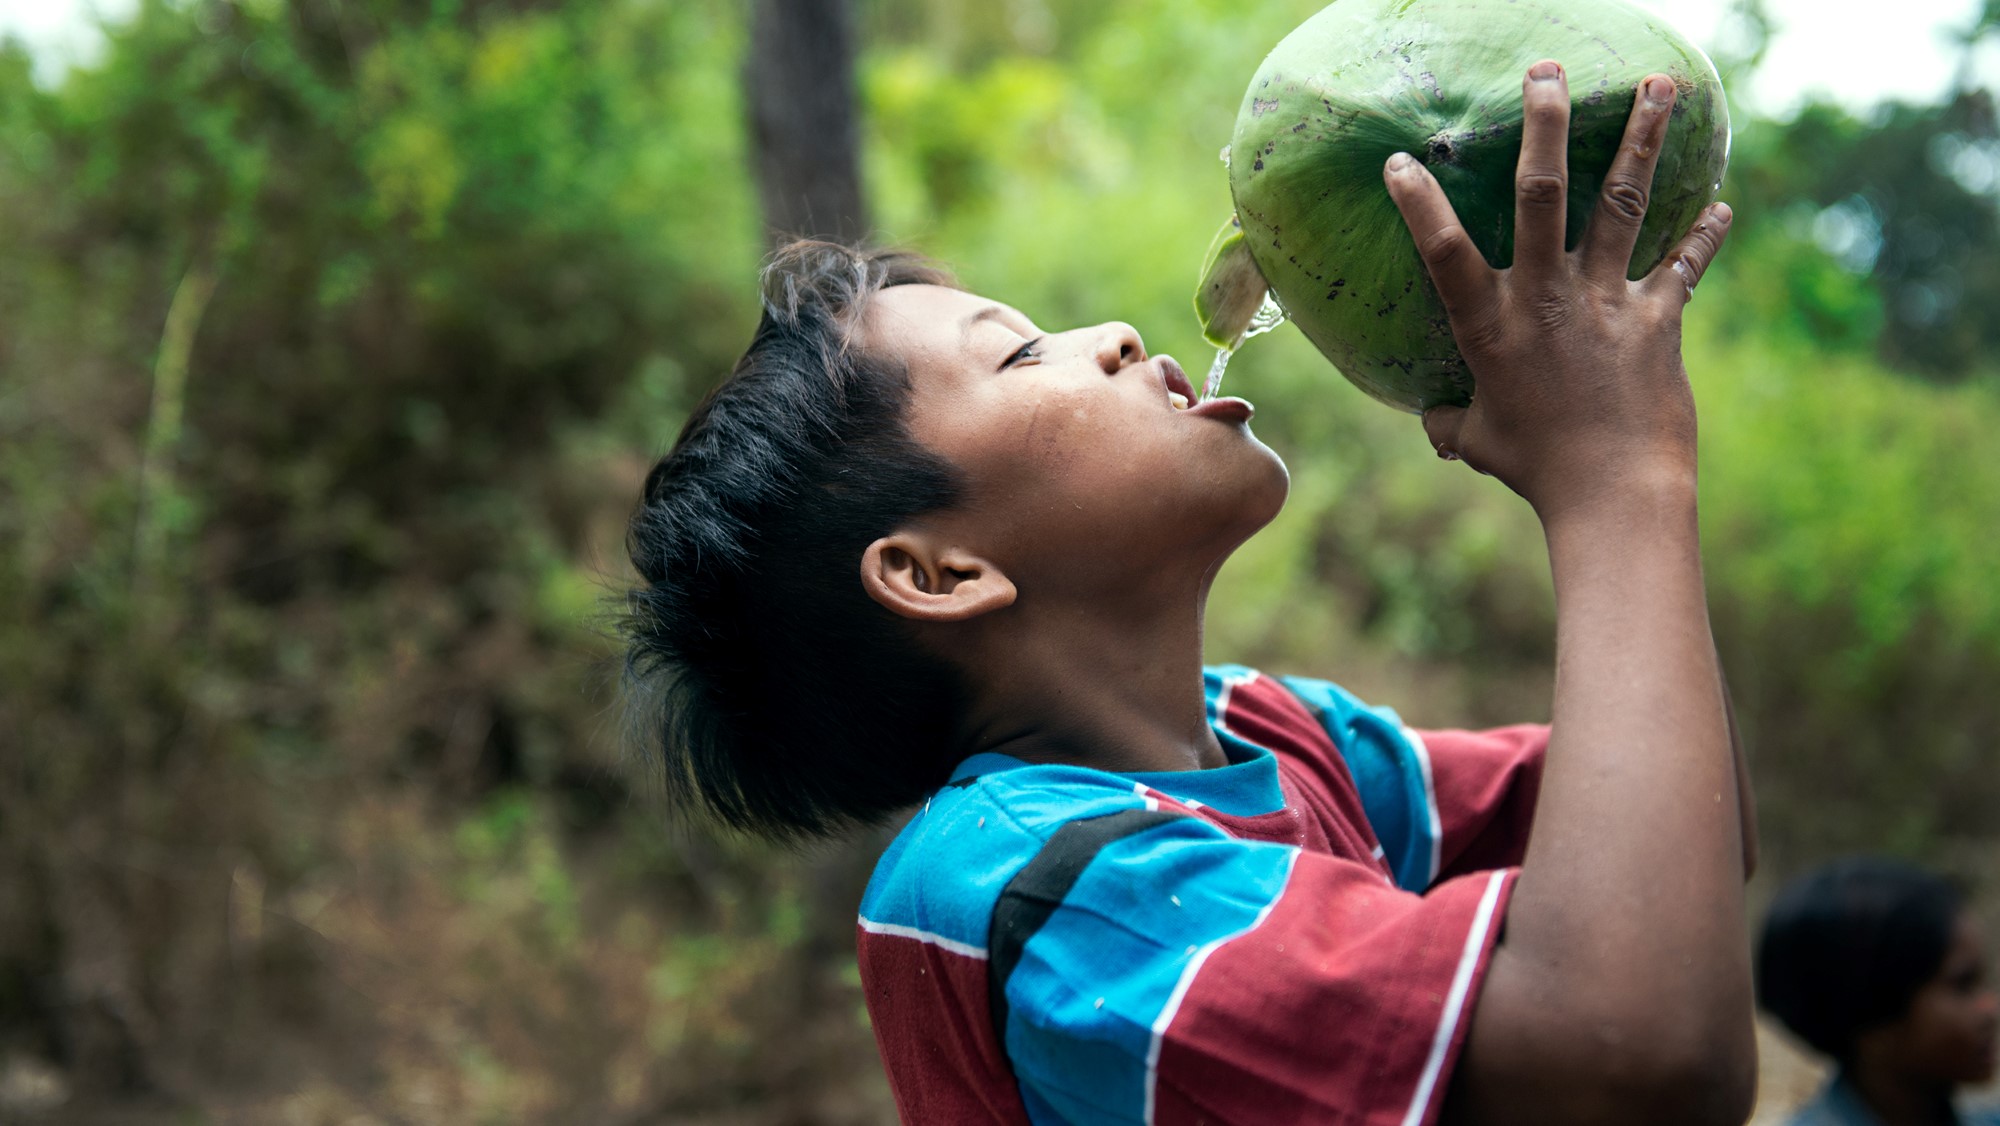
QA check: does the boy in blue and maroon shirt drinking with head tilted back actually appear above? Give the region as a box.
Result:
[630,62,1756,1124]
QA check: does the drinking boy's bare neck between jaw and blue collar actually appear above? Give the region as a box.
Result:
[948,580,1226,774]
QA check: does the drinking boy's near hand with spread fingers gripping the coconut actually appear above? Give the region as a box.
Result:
[1384,60,1730,522]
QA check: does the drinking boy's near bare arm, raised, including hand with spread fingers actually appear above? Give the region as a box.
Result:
[1386,62,1756,1126]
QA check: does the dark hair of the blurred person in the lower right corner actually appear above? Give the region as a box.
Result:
[1756,856,1964,1064]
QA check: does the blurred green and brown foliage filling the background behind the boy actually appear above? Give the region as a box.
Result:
[0,0,2000,1122]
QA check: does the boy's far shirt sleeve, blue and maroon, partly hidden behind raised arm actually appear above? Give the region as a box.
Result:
[1282,676,1548,890]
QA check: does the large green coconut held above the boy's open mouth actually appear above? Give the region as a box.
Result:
[1196,0,1730,412]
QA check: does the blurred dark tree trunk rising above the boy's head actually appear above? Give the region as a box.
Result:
[744,0,868,240]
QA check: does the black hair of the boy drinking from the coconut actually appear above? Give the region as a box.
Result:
[622,242,962,840]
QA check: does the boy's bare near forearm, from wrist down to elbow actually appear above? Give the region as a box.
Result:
[1488,476,1754,1120]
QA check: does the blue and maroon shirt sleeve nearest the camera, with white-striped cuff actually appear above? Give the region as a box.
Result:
[988,810,1512,1126]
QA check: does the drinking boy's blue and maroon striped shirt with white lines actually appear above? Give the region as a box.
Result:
[858,666,1548,1126]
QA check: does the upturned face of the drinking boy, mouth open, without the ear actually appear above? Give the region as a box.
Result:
[860,286,1288,590]
